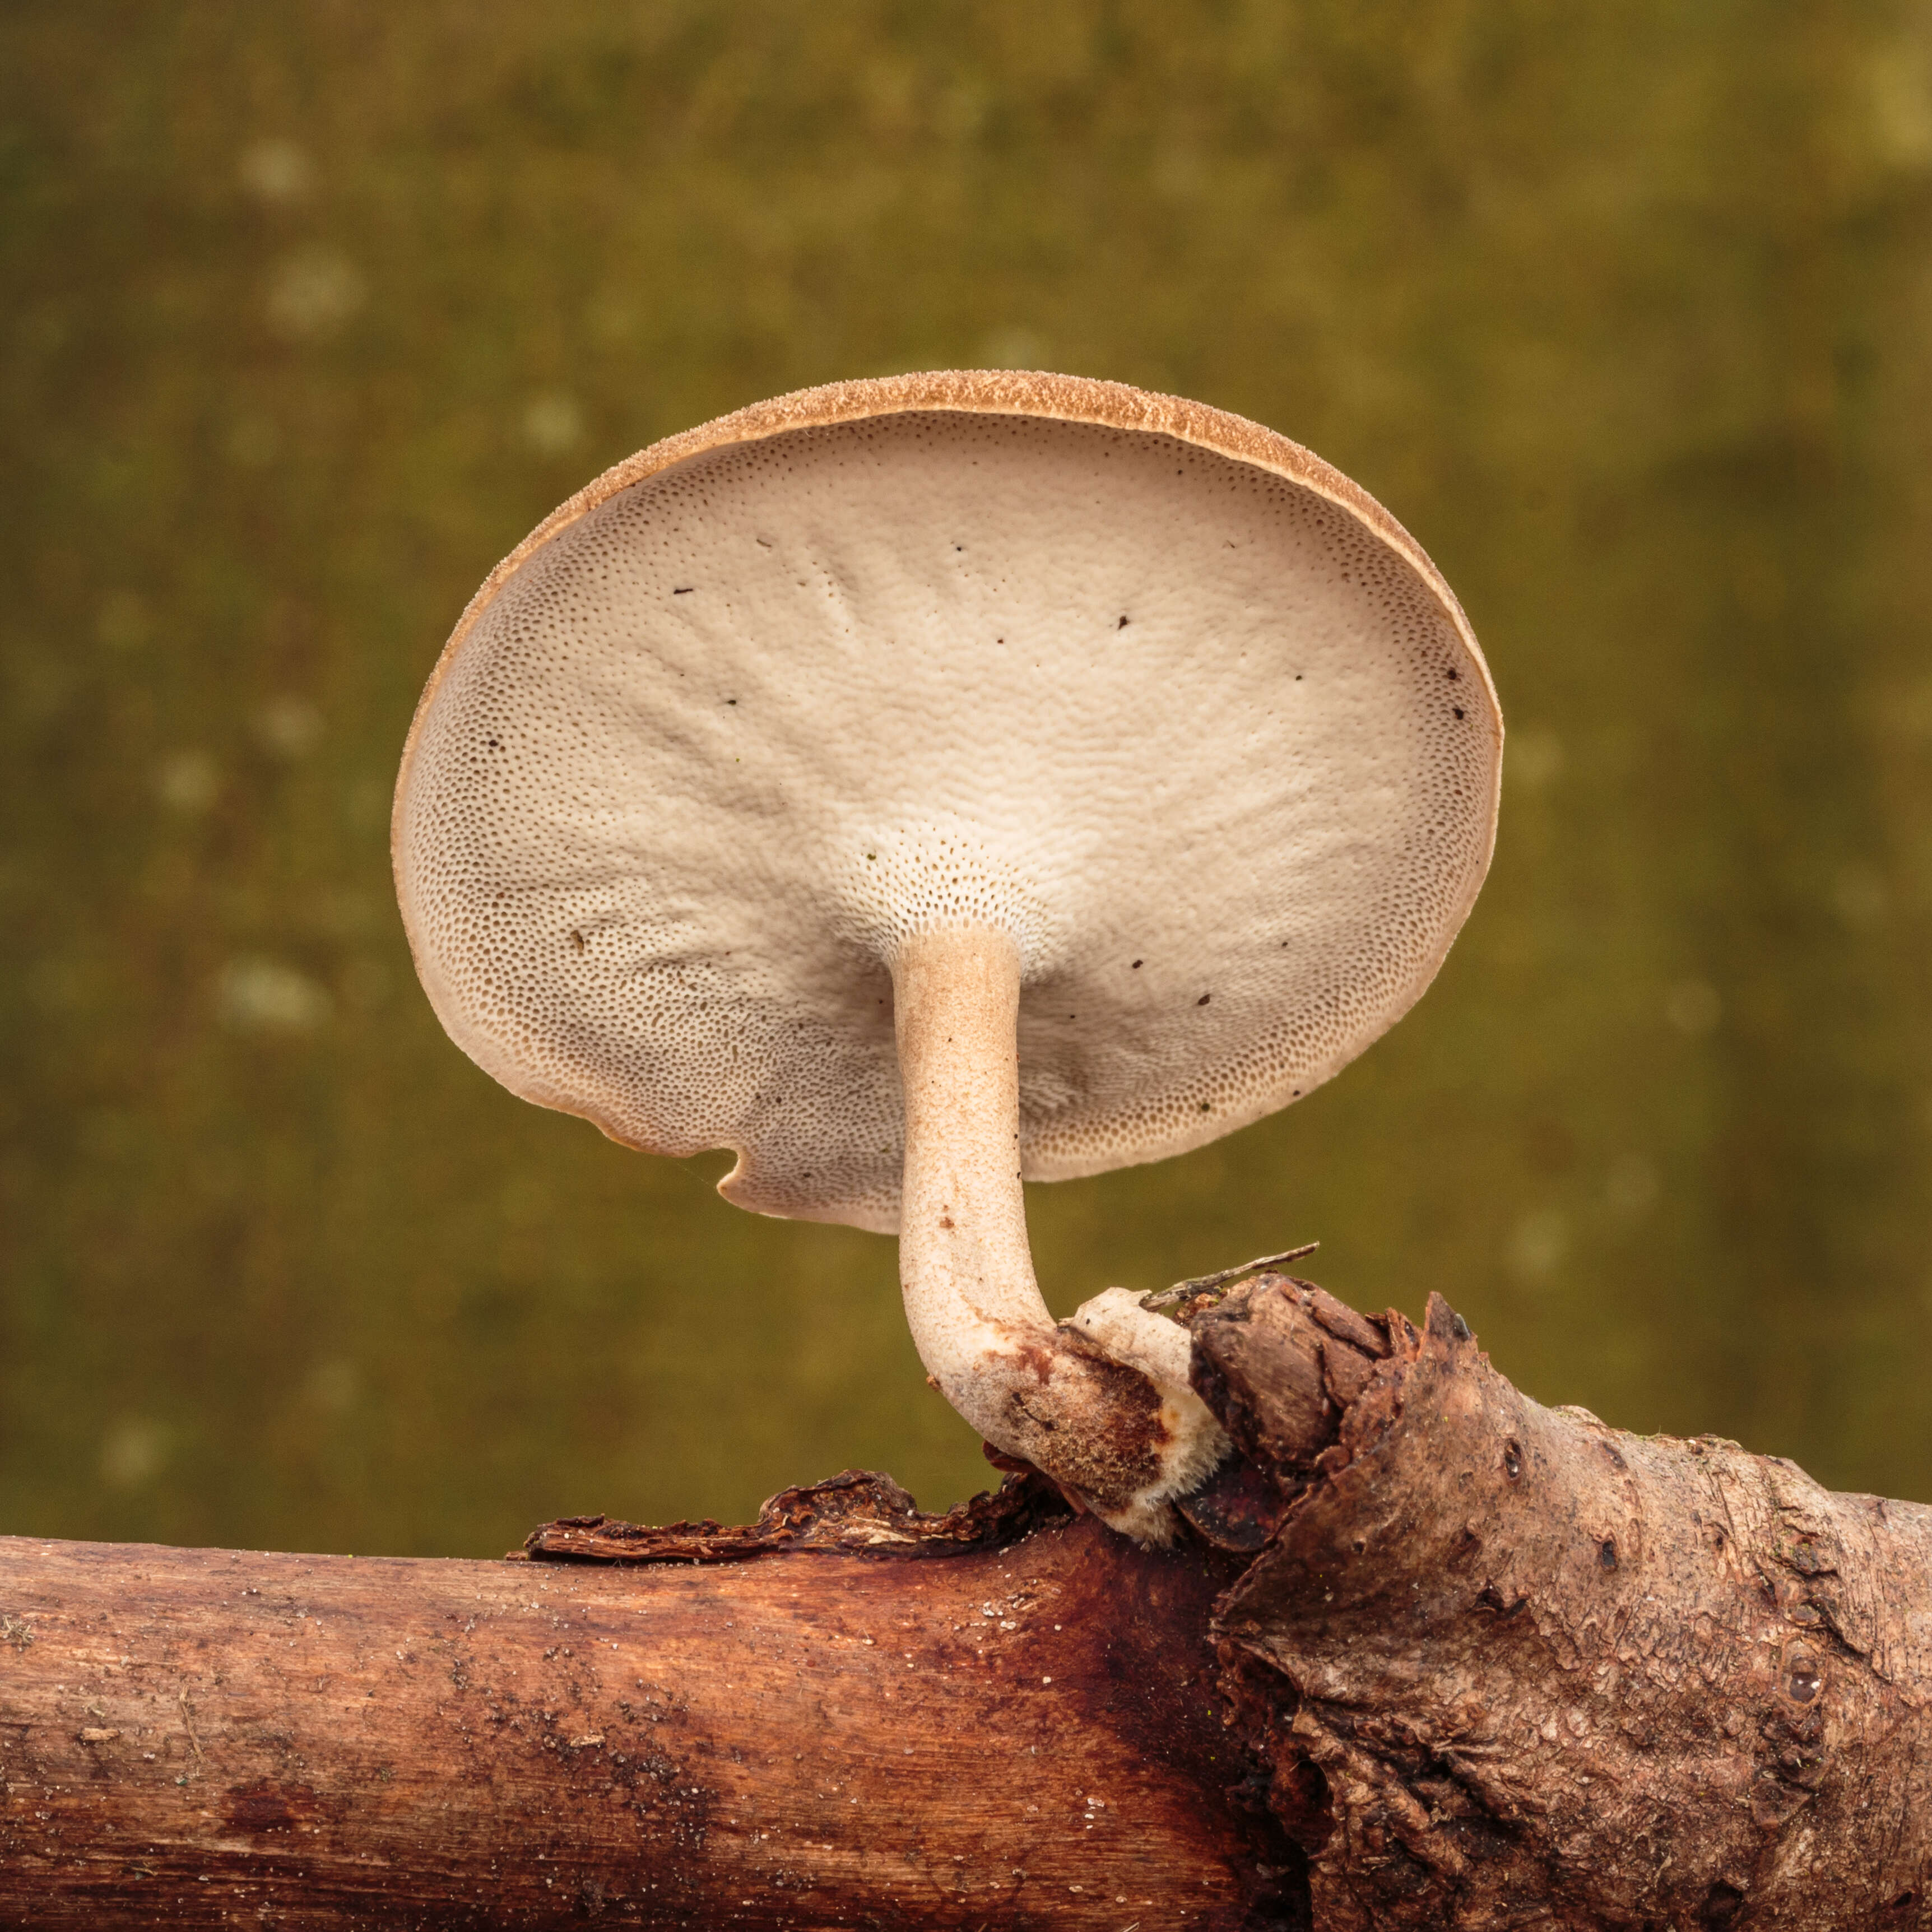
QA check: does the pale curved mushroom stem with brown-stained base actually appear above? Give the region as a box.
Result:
[893,926,1227,1542]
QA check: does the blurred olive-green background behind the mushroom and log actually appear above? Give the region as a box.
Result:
[0,0,1932,1553]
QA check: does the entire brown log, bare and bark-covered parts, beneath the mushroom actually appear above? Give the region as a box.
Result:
[0,1277,1932,1932]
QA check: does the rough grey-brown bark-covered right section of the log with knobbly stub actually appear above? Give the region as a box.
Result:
[1194,1281,1932,1932]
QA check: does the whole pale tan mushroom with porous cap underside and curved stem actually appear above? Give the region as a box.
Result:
[394,371,1501,1542]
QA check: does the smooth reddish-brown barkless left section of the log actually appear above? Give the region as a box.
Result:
[0,1478,1306,1932]
